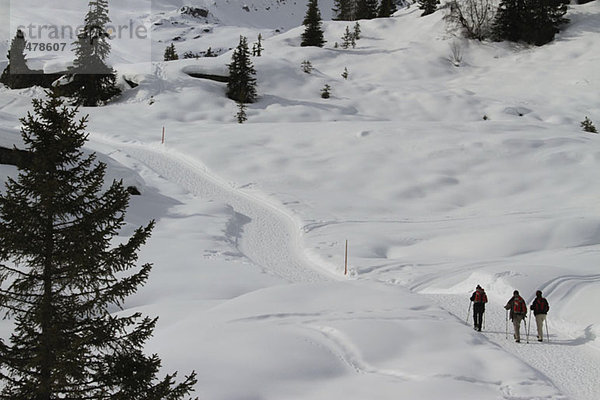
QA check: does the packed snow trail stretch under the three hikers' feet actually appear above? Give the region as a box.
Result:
[429,294,600,400]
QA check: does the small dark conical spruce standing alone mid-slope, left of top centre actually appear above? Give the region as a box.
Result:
[227,36,256,103]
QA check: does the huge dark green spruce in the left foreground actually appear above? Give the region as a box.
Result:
[0,94,196,400]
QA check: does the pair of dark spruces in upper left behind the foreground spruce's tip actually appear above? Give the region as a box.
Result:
[0,0,121,106]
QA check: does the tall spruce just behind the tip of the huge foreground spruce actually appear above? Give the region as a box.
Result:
[68,0,121,106]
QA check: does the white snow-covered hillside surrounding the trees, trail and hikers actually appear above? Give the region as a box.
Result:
[0,0,600,400]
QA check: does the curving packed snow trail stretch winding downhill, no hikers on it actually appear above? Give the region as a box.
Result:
[89,135,335,282]
